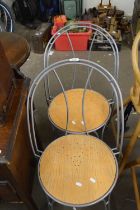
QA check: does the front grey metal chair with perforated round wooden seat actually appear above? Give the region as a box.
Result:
[27,59,124,209]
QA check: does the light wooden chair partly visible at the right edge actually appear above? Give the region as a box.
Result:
[120,32,140,210]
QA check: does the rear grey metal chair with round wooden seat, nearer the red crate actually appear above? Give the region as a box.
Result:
[44,22,119,136]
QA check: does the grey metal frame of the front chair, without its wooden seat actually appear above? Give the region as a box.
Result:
[27,59,124,210]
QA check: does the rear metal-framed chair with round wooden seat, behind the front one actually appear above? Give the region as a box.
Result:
[44,25,119,137]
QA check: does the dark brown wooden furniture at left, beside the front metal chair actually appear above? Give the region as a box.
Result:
[0,39,37,210]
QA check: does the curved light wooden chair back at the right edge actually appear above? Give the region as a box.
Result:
[130,32,140,113]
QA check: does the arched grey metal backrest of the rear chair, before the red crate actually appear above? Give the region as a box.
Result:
[44,21,119,80]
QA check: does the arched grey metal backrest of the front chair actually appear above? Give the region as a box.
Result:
[27,59,124,157]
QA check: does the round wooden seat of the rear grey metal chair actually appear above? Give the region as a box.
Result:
[48,59,114,138]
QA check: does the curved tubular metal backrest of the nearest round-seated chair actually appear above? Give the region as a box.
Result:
[27,59,124,157]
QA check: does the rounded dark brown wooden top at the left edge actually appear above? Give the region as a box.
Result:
[0,32,30,68]
